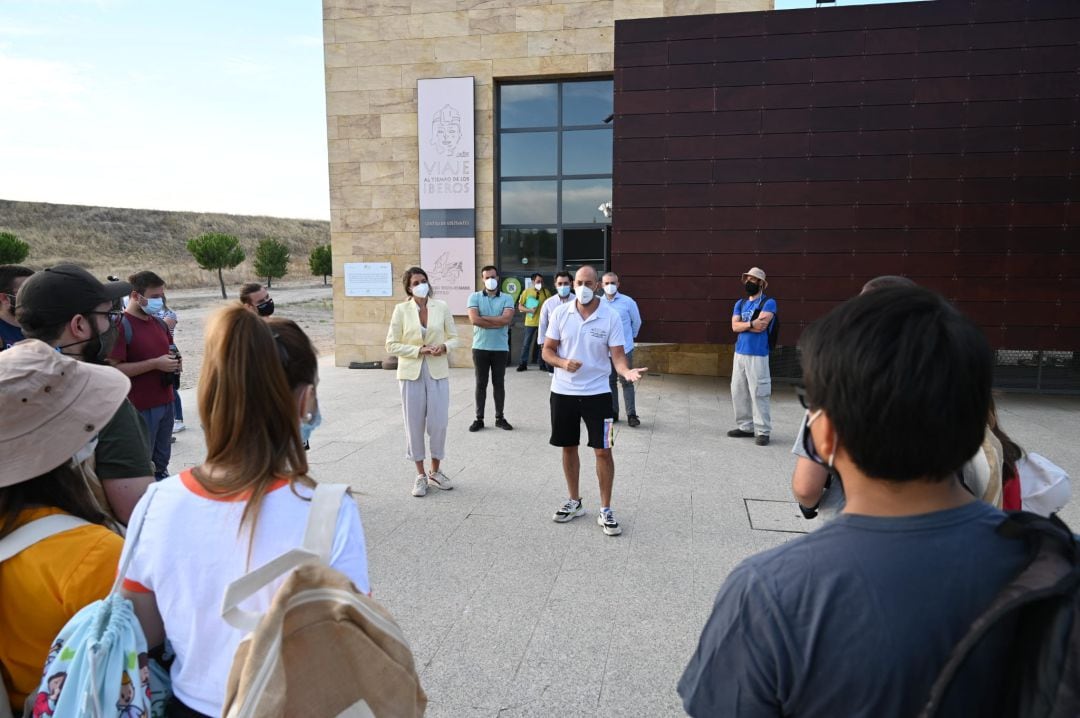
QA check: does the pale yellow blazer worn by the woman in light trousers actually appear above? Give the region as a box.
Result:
[387,299,458,381]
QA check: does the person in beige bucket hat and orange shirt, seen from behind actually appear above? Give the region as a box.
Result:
[0,340,131,715]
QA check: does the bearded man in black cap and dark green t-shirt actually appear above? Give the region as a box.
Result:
[16,265,153,524]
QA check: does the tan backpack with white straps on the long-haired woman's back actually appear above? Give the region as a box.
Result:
[221,484,428,718]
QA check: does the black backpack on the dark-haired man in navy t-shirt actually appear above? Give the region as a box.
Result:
[920,512,1080,718]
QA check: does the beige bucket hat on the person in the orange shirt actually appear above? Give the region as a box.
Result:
[0,339,131,488]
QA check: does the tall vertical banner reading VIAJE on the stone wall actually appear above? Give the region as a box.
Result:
[417,77,476,314]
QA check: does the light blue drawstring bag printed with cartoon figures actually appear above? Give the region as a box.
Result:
[21,485,171,718]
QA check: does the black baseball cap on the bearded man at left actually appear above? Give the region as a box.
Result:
[15,265,132,329]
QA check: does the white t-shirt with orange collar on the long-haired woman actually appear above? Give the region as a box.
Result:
[124,471,370,716]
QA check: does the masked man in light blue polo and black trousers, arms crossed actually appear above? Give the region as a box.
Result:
[469,265,514,431]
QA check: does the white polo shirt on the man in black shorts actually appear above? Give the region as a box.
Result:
[546,301,623,396]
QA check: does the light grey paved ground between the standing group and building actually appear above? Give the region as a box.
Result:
[172,361,1080,718]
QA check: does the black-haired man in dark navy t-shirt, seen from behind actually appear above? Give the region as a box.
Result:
[678,287,1027,718]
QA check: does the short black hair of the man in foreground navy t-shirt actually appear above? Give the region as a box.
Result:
[799,287,994,482]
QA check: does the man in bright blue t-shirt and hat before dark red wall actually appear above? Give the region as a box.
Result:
[728,267,777,446]
